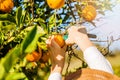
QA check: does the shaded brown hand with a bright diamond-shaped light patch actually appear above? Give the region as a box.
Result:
[46,35,66,72]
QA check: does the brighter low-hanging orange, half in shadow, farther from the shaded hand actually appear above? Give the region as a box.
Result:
[26,51,42,62]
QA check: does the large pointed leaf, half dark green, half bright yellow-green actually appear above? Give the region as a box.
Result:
[21,26,39,53]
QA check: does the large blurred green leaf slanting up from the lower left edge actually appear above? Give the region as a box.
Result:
[0,46,20,80]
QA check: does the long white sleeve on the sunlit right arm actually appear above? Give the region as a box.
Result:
[84,47,113,74]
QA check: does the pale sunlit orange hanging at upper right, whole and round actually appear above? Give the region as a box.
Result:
[82,5,97,22]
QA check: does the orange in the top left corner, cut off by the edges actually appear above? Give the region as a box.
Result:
[0,0,14,13]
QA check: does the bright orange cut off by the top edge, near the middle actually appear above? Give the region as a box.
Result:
[47,0,65,9]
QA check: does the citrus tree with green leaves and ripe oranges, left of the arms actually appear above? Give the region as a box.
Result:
[0,0,114,80]
